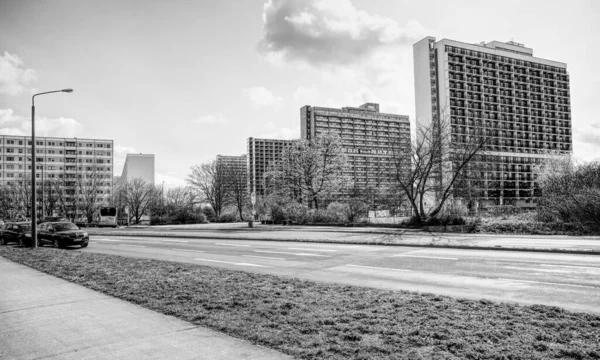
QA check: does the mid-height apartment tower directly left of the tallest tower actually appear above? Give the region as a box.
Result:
[300,103,410,195]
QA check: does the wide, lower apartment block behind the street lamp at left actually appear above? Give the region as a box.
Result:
[0,135,114,214]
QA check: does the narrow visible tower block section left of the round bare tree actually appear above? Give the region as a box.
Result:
[247,137,294,198]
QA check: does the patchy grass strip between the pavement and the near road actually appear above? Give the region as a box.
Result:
[0,247,600,359]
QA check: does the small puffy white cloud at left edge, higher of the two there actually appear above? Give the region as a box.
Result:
[0,51,37,95]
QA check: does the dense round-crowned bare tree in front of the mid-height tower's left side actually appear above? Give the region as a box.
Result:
[265,132,349,209]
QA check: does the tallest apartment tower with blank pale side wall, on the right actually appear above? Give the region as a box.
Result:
[413,37,572,207]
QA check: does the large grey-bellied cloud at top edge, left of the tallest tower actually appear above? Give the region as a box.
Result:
[258,0,426,66]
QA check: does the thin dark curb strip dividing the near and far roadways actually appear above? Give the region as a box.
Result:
[85,233,600,255]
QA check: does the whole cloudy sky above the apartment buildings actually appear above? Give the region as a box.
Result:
[0,0,600,187]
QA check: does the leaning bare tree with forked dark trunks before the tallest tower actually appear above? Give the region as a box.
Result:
[392,117,490,224]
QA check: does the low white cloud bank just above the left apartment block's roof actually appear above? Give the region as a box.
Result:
[0,109,83,137]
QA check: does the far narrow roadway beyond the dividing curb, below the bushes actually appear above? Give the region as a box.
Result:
[87,223,600,251]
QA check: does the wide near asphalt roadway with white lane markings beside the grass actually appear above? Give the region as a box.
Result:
[81,234,600,313]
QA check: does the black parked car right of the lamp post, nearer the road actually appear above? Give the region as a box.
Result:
[37,221,90,248]
